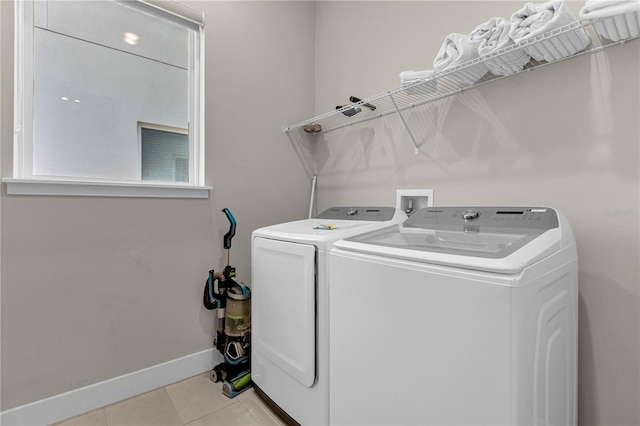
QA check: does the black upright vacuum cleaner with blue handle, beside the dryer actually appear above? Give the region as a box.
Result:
[202,208,252,398]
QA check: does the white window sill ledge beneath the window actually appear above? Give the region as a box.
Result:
[2,178,211,198]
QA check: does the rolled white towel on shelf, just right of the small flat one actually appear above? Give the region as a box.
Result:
[433,33,489,84]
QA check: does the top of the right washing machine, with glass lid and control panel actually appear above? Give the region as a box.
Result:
[335,207,570,273]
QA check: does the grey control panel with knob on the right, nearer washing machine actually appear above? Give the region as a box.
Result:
[405,207,558,231]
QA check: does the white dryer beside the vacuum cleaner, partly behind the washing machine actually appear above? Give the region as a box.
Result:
[251,207,407,424]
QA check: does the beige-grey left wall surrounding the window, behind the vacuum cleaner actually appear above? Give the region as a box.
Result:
[0,1,314,411]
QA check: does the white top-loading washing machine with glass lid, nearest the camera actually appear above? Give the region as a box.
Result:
[329,207,578,425]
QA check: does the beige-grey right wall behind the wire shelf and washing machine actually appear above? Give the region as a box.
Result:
[314,1,640,425]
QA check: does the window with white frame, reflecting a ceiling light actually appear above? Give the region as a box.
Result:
[6,0,208,196]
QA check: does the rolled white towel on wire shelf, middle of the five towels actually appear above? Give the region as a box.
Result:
[469,18,531,75]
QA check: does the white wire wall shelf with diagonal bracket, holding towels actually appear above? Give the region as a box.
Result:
[282,21,638,141]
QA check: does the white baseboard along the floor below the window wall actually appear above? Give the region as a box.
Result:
[0,348,221,426]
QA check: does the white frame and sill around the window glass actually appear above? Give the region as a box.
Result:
[2,0,212,198]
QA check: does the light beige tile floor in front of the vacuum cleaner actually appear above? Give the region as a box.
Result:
[51,372,286,426]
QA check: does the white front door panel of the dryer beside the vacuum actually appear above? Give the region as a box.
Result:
[251,237,316,387]
